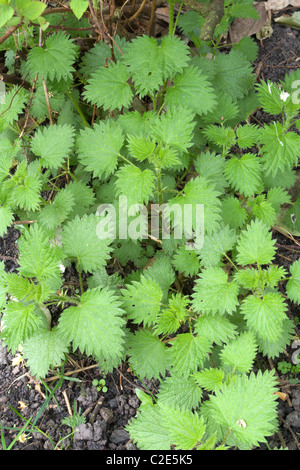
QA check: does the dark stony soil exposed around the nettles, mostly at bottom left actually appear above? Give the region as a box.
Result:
[0,7,300,450]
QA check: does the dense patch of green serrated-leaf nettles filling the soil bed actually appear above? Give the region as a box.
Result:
[0,7,300,450]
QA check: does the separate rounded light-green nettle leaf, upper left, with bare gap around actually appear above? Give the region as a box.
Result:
[31,124,75,169]
